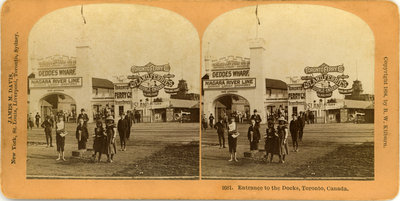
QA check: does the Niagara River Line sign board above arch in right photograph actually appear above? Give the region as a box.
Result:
[203,78,256,90]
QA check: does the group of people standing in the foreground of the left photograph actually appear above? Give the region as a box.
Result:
[41,109,132,162]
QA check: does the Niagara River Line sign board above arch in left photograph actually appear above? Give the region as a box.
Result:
[29,77,82,88]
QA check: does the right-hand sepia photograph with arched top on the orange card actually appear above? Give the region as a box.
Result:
[201,4,375,180]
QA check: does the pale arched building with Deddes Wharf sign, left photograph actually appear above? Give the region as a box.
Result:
[28,55,114,121]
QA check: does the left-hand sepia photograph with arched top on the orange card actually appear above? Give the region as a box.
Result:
[26,4,200,179]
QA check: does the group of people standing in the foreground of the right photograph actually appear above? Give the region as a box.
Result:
[214,110,305,163]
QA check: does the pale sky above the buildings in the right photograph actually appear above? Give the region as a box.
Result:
[202,4,375,93]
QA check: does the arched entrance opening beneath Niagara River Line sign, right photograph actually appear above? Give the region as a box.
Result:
[214,95,250,122]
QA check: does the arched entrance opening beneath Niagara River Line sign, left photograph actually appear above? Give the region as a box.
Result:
[39,93,76,122]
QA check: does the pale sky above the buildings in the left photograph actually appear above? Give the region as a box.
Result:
[28,4,200,93]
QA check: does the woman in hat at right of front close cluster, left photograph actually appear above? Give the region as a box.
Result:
[104,115,117,163]
